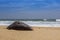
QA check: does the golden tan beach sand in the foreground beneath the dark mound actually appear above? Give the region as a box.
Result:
[0,26,60,40]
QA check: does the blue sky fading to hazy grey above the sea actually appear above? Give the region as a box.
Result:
[0,0,60,19]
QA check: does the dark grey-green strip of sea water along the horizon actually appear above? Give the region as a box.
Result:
[0,19,56,21]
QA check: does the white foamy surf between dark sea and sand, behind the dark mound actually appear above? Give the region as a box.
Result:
[0,21,60,27]
